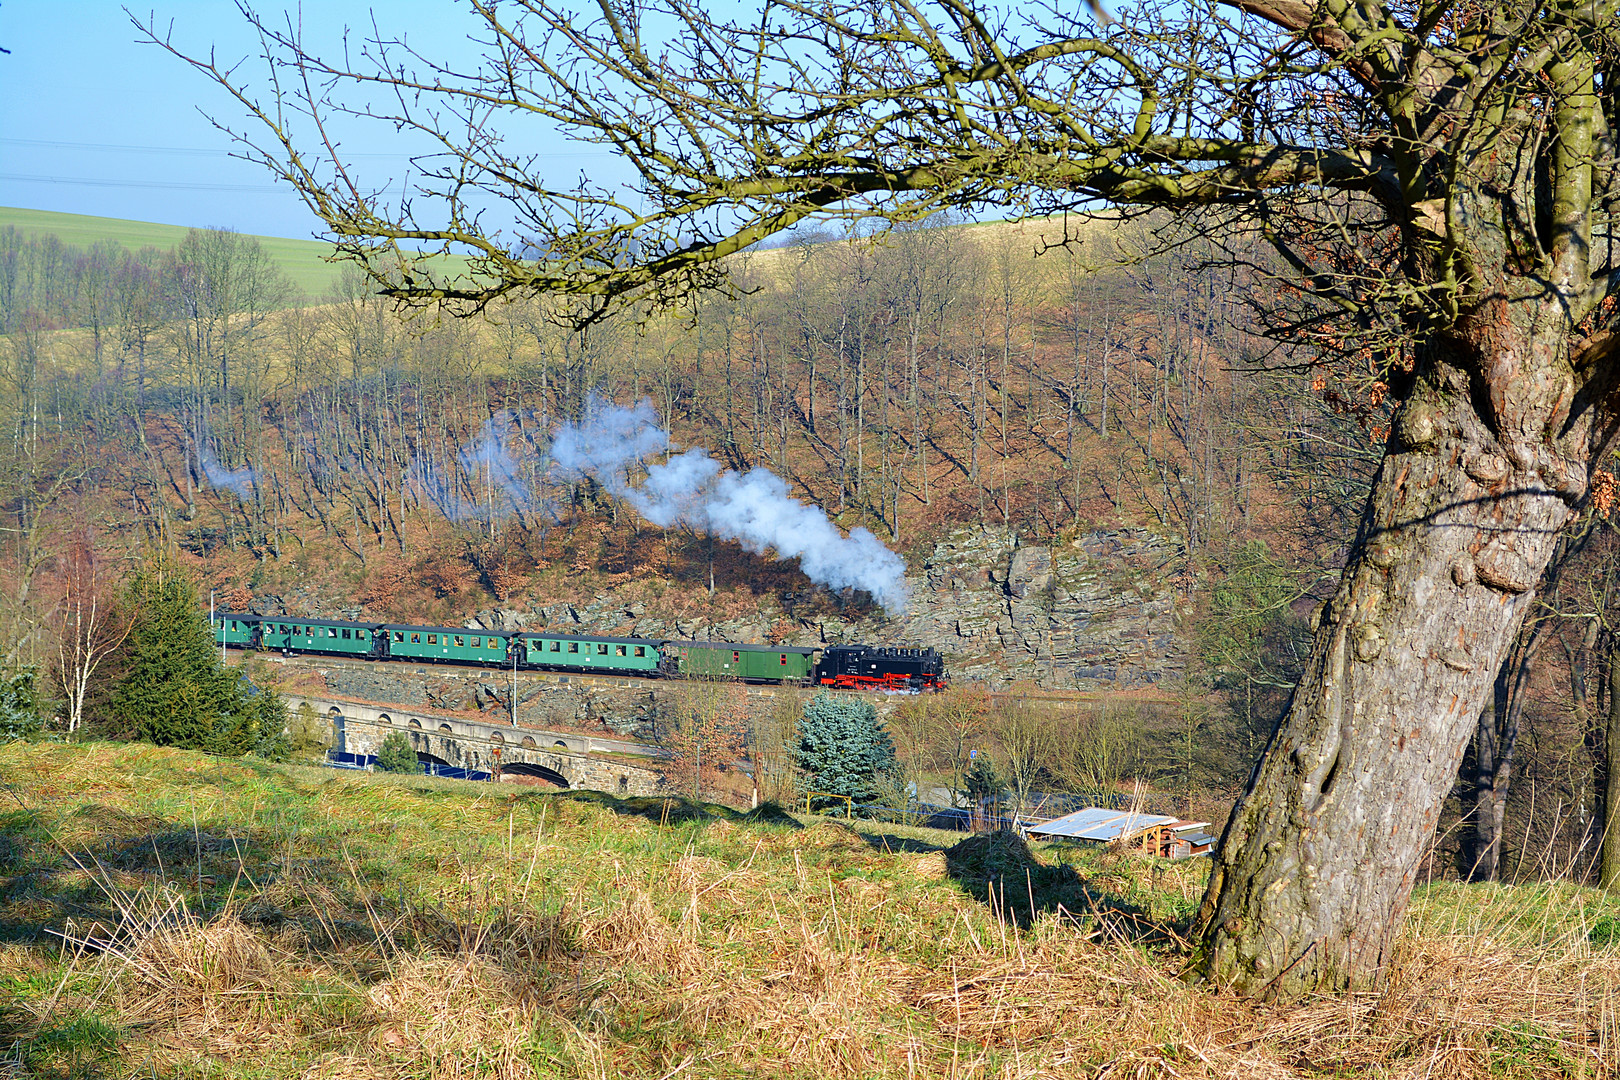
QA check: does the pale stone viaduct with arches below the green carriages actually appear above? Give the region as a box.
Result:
[287,695,663,795]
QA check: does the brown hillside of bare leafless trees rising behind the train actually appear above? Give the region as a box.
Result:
[15,210,1617,873]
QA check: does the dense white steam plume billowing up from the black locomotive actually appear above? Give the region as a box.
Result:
[551,400,907,615]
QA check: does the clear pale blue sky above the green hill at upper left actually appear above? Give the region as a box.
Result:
[0,0,611,236]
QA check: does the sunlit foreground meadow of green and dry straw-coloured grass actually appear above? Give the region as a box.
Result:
[0,745,1620,1078]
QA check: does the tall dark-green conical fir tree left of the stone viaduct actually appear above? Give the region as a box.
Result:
[110,565,258,755]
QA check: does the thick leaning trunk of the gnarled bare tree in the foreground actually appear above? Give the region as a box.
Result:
[1192,318,1591,997]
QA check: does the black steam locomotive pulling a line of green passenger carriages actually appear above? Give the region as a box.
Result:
[212,612,946,690]
